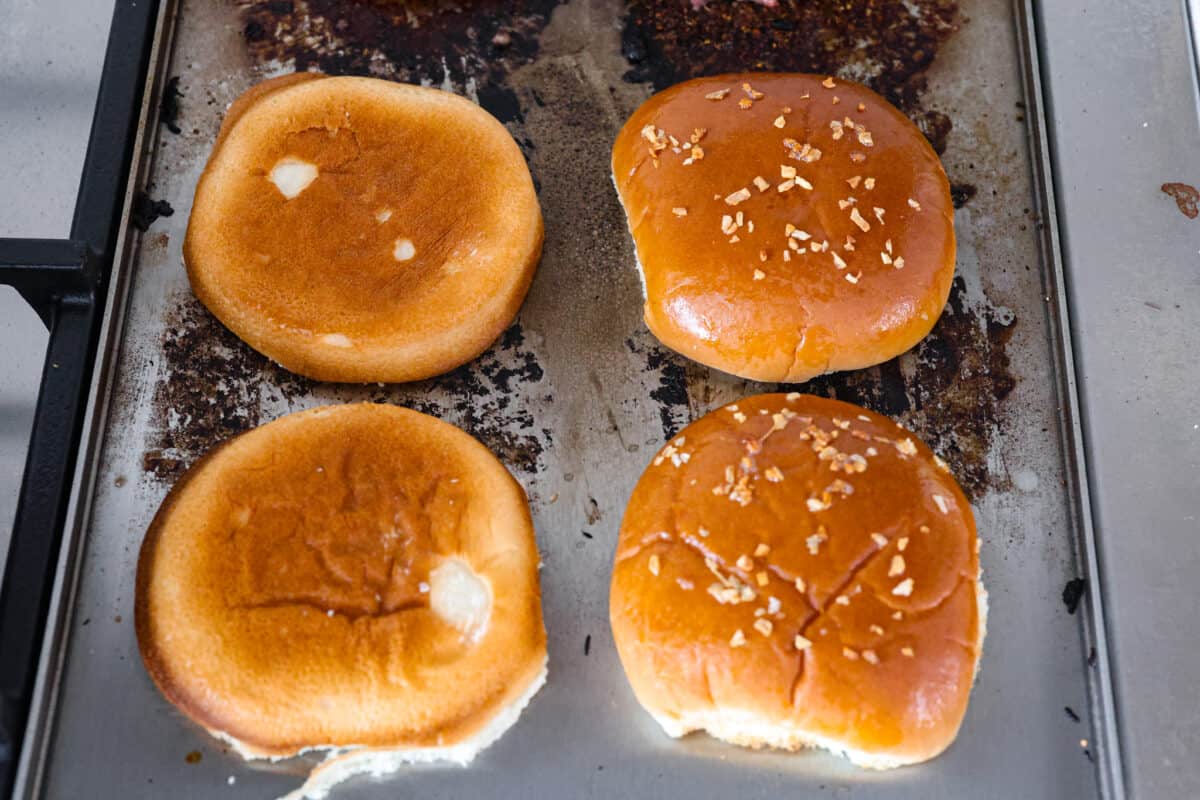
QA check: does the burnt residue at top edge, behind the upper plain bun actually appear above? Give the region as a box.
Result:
[238,0,559,122]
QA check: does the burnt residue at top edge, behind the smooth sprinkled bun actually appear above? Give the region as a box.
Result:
[623,0,959,154]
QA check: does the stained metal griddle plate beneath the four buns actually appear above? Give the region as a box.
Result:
[20,0,1112,800]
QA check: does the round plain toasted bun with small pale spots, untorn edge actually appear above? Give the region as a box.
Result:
[184,73,542,383]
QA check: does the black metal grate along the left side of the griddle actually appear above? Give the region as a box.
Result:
[0,0,160,796]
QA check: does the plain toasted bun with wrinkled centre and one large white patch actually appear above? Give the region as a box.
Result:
[137,404,546,756]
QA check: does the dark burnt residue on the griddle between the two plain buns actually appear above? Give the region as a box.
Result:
[142,294,551,483]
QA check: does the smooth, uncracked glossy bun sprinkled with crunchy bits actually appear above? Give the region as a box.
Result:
[612,73,954,381]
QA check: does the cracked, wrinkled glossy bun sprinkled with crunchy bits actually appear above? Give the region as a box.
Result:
[611,395,982,763]
